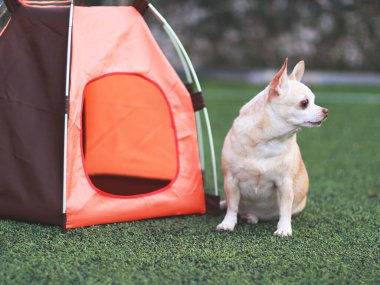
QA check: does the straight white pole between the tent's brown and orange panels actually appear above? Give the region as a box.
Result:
[62,0,74,219]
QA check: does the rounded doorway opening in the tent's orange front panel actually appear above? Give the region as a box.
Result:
[82,73,178,196]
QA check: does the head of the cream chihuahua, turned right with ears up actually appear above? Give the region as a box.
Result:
[268,59,329,128]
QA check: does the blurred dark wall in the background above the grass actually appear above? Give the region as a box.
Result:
[0,0,380,72]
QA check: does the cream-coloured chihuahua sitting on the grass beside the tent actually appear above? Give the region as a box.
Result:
[217,59,329,237]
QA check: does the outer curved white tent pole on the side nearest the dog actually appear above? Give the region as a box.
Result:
[148,3,219,196]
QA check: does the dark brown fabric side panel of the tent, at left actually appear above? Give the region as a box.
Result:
[0,1,69,225]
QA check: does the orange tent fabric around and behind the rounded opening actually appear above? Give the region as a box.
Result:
[66,7,205,228]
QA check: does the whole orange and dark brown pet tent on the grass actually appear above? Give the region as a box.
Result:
[0,0,216,228]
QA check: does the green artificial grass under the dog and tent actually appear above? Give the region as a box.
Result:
[0,83,380,284]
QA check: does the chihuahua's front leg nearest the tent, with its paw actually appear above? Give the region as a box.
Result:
[216,175,240,231]
